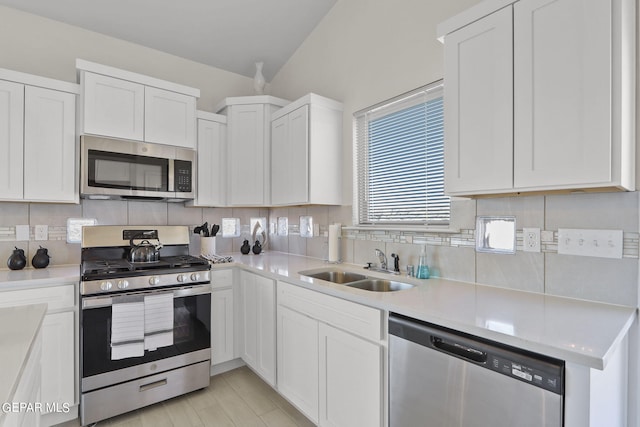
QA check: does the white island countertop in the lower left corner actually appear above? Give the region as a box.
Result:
[0,304,47,412]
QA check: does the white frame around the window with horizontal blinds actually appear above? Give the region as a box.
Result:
[353,80,451,229]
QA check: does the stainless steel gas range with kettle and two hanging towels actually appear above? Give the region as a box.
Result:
[80,226,211,425]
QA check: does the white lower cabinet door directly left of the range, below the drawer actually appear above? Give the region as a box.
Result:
[41,312,76,407]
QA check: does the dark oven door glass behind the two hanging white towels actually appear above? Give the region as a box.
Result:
[81,294,211,378]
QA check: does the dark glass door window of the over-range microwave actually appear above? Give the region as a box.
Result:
[89,150,169,191]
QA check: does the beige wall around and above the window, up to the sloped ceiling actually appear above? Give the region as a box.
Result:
[271,0,479,205]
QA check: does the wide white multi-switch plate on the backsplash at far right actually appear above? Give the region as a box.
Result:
[558,228,623,258]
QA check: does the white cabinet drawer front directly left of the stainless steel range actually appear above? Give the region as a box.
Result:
[0,285,77,311]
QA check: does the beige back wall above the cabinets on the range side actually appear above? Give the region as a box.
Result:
[0,6,253,112]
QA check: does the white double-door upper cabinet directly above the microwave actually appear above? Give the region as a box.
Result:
[76,59,200,148]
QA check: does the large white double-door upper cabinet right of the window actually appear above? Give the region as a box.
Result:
[438,0,636,196]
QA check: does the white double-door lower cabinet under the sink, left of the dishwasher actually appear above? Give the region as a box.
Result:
[277,282,384,427]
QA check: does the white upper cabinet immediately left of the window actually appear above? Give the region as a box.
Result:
[271,94,342,205]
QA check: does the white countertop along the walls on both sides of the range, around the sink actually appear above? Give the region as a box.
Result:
[0,252,636,369]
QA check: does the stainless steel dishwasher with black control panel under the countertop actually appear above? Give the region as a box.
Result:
[389,313,564,427]
